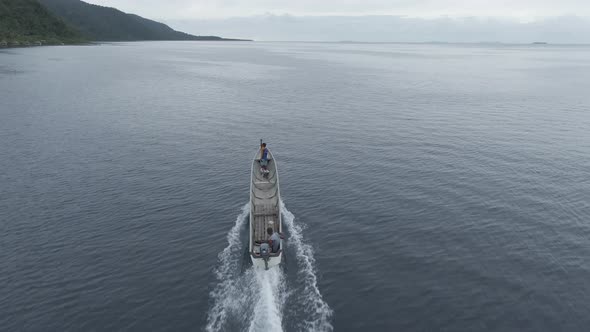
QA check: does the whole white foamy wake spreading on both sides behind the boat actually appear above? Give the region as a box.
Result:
[205,202,333,332]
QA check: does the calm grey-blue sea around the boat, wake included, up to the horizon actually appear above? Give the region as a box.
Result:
[0,42,590,331]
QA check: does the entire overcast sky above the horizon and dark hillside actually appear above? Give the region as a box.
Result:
[85,0,590,43]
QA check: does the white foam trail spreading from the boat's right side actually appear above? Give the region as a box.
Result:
[281,201,334,331]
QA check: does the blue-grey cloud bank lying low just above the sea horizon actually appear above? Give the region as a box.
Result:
[167,15,590,43]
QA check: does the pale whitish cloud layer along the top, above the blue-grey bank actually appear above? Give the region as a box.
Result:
[86,0,590,19]
